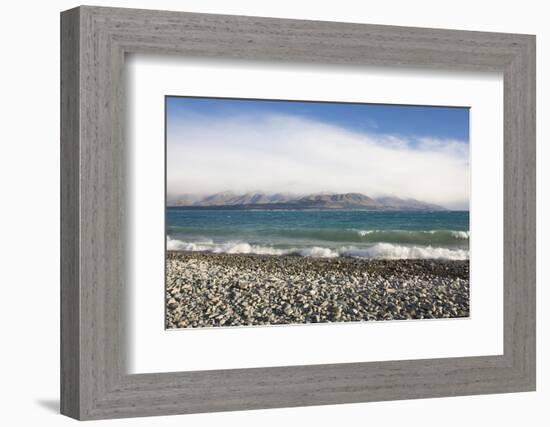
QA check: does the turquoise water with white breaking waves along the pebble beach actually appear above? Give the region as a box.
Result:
[166,207,470,259]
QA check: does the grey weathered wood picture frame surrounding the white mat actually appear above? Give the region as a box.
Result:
[61,6,535,419]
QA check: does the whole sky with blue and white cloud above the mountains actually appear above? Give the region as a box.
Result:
[166,97,470,209]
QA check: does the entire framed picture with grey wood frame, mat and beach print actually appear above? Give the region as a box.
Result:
[61,6,536,420]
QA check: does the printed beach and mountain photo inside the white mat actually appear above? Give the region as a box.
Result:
[165,96,470,329]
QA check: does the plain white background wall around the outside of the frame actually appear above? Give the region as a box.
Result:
[0,0,550,427]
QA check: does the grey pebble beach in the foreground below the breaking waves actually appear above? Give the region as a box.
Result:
[166,252,470,328]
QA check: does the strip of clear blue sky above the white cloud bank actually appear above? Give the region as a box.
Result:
[166,96,469,143]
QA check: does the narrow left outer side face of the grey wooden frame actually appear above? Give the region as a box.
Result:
[60,10,80,417]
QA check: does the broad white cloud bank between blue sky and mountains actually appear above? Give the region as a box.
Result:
[167,115,469,208]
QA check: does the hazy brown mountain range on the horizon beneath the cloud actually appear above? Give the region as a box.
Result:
[167,191,446,211]
